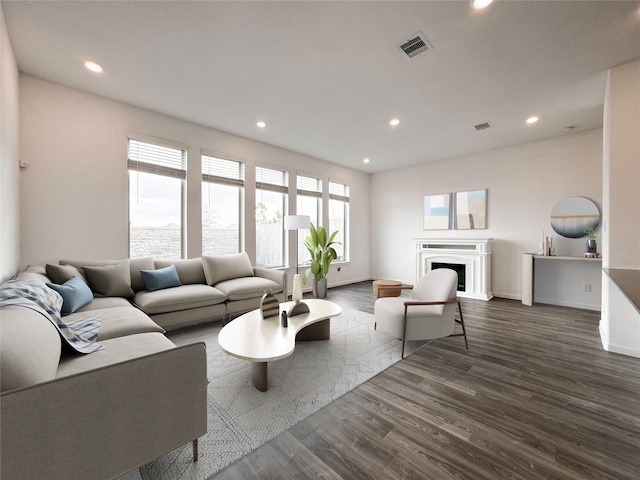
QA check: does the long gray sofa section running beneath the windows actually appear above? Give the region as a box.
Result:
[52,253,287,330]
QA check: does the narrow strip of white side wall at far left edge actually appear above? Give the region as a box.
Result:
[0,6,20,281]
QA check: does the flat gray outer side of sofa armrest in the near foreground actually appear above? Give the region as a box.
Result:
[0,343,207,480]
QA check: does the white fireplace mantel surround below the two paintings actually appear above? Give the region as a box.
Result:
[413,238,493,300]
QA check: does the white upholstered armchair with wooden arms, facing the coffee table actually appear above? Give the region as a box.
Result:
[374,268,469,358]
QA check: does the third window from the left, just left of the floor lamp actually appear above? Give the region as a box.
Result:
[256,167,289,267]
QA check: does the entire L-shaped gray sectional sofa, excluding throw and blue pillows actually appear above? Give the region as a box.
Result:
[0,254,287,480]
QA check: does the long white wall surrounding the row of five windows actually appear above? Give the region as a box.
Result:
[20,74,370,286]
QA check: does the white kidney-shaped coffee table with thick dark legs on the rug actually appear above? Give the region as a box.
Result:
[218,298,342,392]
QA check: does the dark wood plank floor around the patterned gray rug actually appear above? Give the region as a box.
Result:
[213,282,640,480]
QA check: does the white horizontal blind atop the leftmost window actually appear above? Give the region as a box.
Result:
[127,138,187,180]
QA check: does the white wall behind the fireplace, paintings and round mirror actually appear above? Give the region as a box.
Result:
[371,127,602,304]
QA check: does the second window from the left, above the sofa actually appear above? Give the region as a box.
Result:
[202,154,244,255]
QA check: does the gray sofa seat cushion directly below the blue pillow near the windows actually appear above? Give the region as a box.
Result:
[133,285,227,315]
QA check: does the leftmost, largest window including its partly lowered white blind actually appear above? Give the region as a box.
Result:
[127,138,187,259]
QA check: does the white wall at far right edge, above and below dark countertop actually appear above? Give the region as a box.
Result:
[600,61,640,357]
